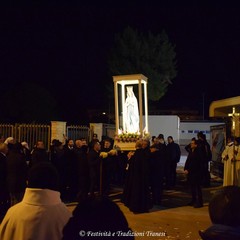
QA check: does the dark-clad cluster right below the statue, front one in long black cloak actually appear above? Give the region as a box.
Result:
[122,134,181,213]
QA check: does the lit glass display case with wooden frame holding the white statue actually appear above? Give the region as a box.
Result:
[113,74,149,150]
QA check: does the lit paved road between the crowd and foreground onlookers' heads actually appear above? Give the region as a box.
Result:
[67,170,222,240]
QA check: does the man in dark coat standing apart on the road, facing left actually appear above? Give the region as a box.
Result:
[184,139,204,208]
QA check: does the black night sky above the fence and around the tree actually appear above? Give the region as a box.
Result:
[0,2,240,124]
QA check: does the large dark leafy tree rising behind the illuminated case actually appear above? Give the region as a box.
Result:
[109,27,176,101]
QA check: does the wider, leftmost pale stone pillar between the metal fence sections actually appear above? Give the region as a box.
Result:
[51,121,67,144]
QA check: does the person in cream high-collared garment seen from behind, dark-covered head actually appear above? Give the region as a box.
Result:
[0,162,71,240]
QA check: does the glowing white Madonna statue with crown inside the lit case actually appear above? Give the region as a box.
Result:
[124,86,139,133]
